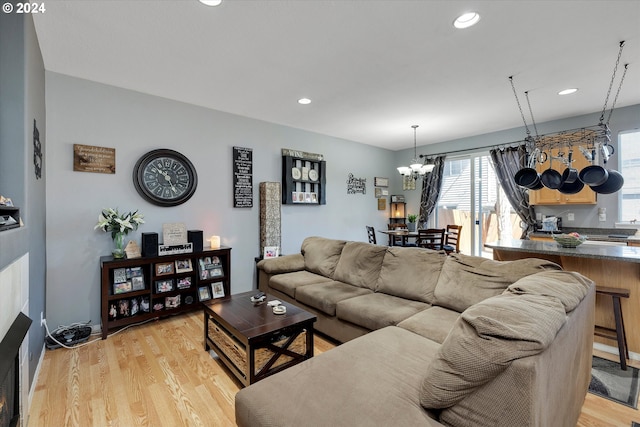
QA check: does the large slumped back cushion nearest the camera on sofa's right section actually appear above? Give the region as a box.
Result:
[420,294,566,409]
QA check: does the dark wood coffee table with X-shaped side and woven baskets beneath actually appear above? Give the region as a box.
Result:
[203,291,316,386]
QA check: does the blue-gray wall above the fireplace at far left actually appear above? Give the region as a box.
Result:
[0,7,46,388]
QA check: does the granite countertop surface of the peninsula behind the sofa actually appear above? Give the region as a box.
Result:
[485,239,640,263]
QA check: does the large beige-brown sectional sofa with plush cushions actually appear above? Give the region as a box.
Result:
[236,237,595,427]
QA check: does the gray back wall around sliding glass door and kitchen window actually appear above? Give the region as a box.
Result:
[395,104,640,228]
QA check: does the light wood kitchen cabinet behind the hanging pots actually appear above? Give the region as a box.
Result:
[529,147,597,205]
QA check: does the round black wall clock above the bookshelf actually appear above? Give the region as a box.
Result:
[133,148,198,206]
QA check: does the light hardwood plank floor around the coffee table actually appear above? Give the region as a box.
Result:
[28,312,640,427]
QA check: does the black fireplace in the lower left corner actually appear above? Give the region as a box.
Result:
[0,313,31,427]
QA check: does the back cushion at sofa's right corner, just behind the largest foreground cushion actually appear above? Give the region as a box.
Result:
[505,271,593,313]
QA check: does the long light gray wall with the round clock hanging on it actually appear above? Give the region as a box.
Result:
[46,72,399,325]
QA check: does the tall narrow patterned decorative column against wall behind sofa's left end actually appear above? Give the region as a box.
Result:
[260,182,282,257]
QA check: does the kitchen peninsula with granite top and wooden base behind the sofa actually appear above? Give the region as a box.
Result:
[485,240,640,357]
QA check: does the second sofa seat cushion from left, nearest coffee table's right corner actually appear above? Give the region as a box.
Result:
[296,280,373,316]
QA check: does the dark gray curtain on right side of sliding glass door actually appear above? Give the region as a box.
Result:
[490,145,536,239]
